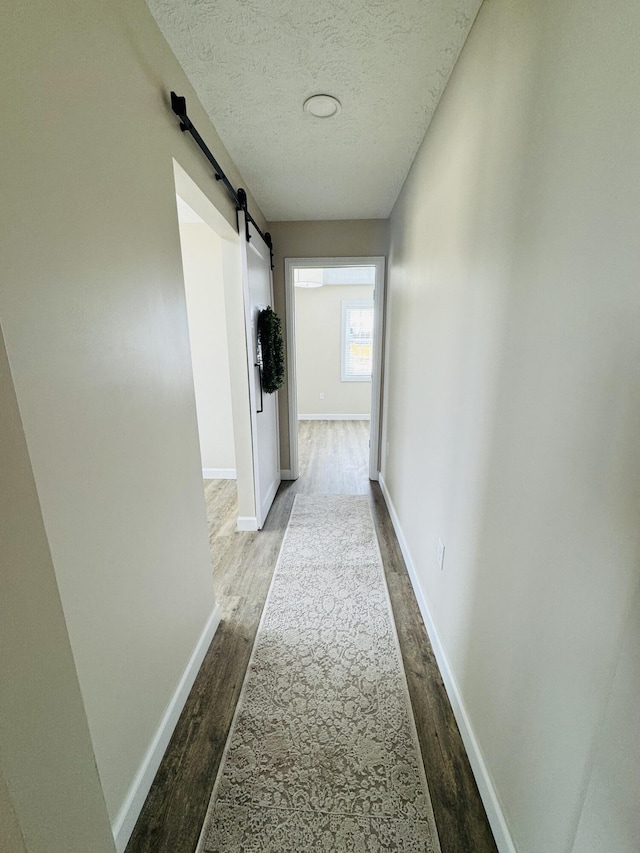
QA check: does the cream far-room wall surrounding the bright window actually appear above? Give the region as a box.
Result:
[295,285,373,415]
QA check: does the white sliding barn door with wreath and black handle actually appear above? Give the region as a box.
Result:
[238,211,280,530]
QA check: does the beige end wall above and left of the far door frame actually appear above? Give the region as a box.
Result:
[268,219,389,469]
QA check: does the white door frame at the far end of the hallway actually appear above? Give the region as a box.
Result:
[284,255,385,480]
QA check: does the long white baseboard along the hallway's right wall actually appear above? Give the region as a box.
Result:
[378,474,517,853]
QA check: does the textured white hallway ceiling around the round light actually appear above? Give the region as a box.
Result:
[147,0,481,222]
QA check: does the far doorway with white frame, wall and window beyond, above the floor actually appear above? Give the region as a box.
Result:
[285,257,384,480]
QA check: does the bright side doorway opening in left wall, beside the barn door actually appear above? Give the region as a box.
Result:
[174,160,256,530]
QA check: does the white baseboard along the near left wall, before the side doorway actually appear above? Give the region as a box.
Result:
[113,604,222,853]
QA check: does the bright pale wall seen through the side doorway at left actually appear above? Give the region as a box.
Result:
[180,223,236,471]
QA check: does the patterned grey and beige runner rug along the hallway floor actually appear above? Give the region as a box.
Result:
[198,495,440,853]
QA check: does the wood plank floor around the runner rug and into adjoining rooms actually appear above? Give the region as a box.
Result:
[126,421,496,853]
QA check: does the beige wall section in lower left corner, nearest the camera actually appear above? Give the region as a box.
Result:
[0,322,115,853]
